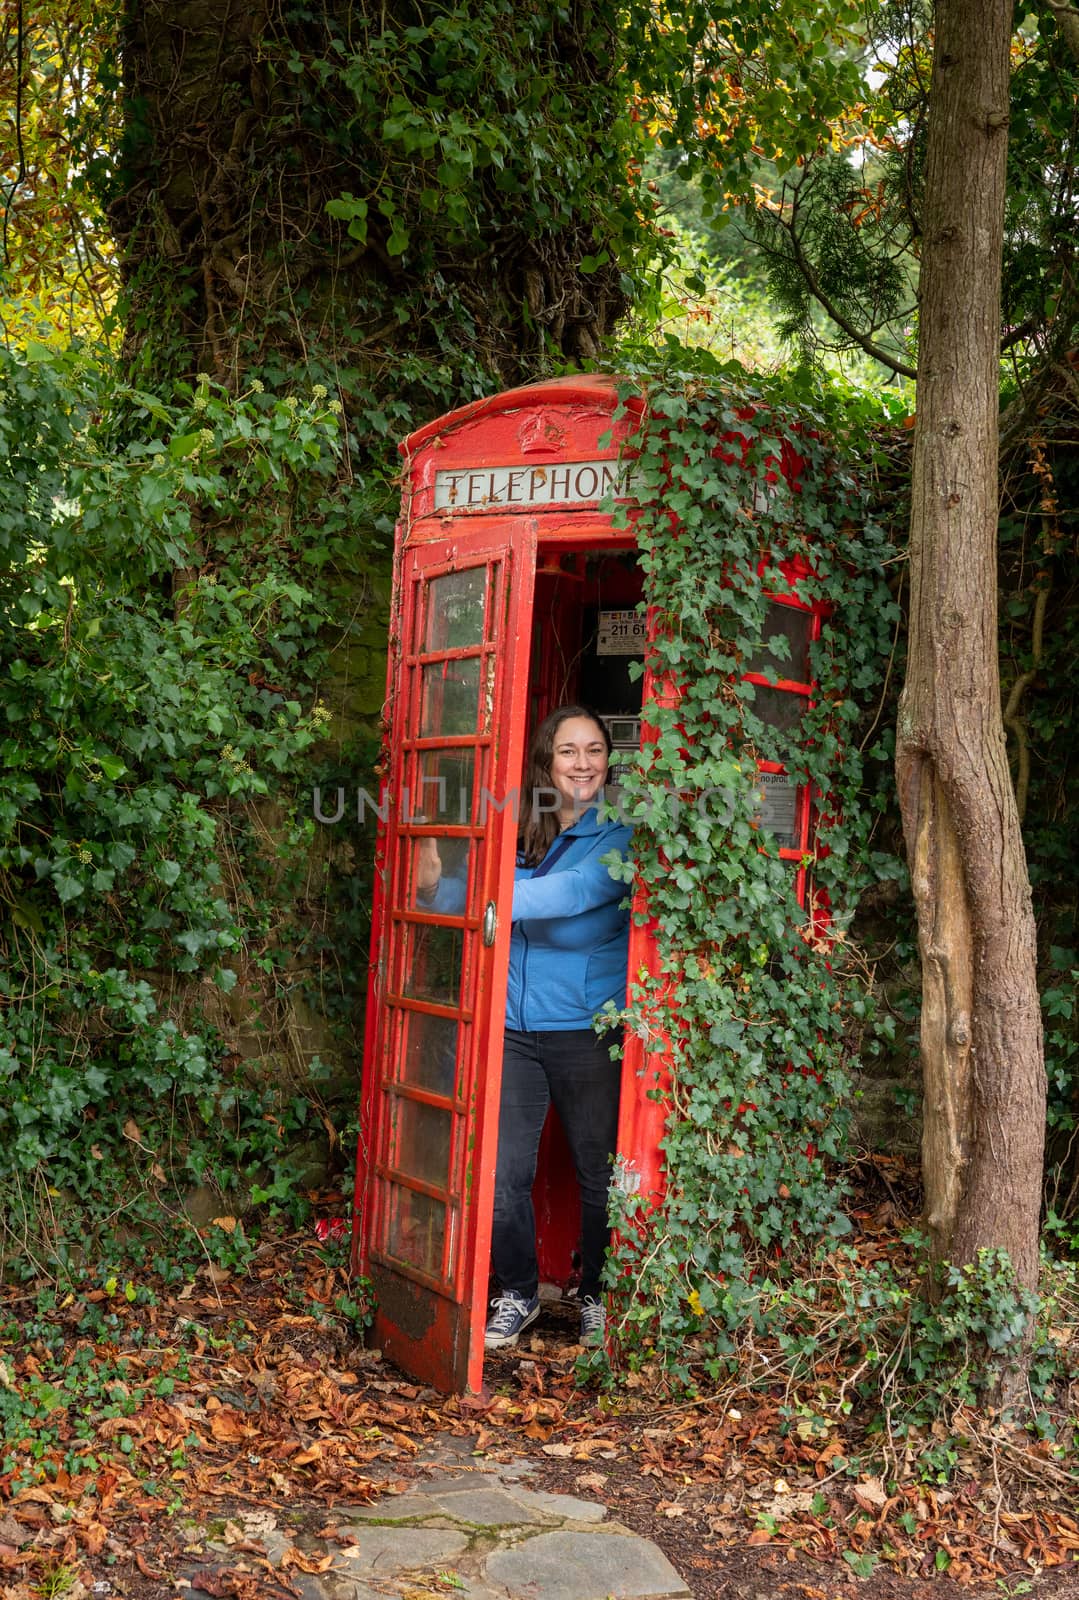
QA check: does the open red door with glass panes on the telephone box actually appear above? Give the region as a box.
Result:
[357,518,536,1390]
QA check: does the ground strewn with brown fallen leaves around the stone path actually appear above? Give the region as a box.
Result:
[0,1177,1079,1600]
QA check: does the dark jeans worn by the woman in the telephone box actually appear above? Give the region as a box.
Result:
[491,1027,621,1299]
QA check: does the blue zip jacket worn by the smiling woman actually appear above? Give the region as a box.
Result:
[427,806,631,1034]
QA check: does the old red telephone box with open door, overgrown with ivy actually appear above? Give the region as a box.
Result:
[352,376,823,1390]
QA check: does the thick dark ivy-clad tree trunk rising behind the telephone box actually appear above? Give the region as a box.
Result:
[110,0,626,384]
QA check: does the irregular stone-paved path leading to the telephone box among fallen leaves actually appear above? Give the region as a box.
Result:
[206,1437,690,1600]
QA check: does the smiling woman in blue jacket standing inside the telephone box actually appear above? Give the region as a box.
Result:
[418,706,629,1349]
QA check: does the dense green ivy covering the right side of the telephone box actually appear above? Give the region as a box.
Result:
[601,368,895,1373]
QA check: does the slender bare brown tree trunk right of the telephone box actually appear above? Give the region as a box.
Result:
[896,0,1045,1288]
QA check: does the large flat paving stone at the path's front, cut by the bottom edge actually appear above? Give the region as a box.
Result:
[483,1530,690,1600]
